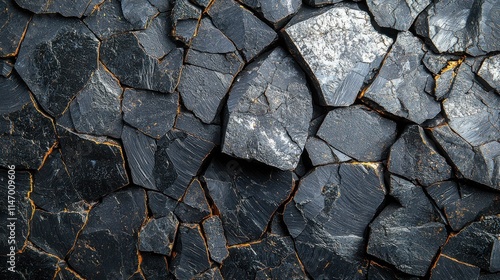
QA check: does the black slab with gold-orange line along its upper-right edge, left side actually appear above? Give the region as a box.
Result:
[58,127,129,202]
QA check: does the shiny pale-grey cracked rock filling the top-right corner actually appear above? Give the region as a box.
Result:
[415,0,500,56]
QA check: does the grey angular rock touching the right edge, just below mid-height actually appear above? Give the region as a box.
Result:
[430,125,500,189]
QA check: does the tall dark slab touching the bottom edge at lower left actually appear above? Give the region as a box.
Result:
[68,188,146,279]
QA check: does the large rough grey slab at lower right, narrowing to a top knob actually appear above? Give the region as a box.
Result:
[367,176,447,276]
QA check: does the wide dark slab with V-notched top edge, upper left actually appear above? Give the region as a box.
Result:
[100,32,183,92]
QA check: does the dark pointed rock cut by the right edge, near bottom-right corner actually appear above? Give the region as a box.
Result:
[442,215,500,272]
